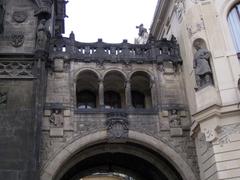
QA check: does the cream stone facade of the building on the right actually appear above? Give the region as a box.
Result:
[150,0,240,180]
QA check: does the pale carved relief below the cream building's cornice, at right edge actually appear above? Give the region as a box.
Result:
[216,123,240,146]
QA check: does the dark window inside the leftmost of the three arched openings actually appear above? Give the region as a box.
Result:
[77,90,96,109]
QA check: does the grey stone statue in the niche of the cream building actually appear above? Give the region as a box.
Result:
[193,41,213,88]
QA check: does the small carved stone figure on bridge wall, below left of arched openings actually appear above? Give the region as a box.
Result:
[49,109,64,128]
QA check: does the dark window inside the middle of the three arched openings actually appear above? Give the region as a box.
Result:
[104,91,121,109]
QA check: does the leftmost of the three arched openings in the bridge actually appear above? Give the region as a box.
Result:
[76,70,98,109]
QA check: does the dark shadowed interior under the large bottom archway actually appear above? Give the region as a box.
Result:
[55,144,182,180]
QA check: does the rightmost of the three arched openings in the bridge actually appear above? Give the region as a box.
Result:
[131,71,152,108]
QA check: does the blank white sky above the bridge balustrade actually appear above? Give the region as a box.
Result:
[64,0,158,43]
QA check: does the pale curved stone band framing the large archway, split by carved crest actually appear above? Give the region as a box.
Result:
[41,131,197,180]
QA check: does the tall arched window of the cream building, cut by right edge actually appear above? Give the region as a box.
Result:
[228,3,240,57]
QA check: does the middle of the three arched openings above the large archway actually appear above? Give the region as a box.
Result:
[104,71,125,109]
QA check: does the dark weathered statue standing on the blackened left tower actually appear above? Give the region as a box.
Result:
[36,19,51,50]
